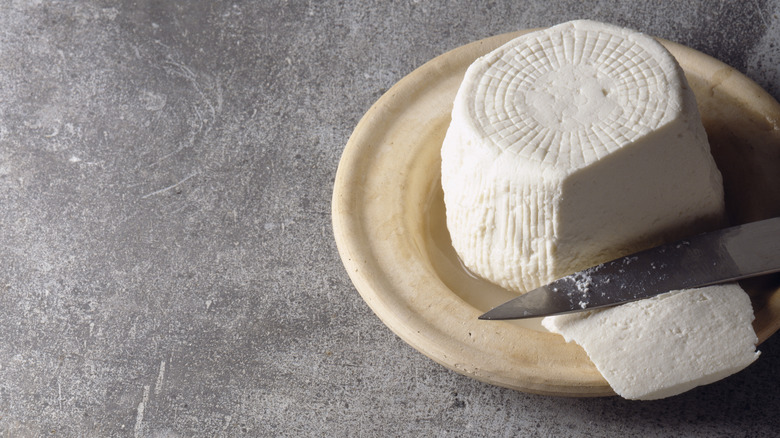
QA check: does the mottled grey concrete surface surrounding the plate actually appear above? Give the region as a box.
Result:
[0,0,780,437]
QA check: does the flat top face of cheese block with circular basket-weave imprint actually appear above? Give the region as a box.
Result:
[453,20,684,170]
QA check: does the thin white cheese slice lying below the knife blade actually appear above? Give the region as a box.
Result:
[542,284,760,400]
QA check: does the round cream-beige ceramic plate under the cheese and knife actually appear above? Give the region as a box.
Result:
[333,31,780,396]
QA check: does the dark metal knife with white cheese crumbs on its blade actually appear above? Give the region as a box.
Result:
[479,217,780,320]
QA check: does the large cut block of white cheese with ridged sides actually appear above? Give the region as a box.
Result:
[441,21,724,292]
